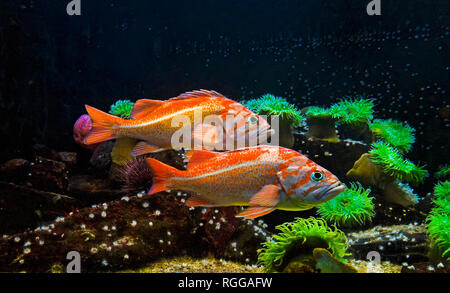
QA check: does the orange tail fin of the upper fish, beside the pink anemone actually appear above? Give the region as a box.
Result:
[84,105,122,144]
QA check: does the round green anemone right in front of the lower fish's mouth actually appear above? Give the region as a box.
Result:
[318,182,375,227]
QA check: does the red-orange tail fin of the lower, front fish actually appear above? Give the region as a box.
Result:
[147,158,183,194]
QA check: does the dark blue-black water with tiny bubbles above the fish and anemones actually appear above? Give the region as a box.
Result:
[0,0,450,171]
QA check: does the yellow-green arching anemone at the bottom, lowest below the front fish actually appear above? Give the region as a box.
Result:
[258,217,349,272]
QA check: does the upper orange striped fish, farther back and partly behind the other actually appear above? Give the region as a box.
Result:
[84,90,273,156]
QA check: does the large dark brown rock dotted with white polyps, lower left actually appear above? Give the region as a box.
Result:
[0,192,265,272]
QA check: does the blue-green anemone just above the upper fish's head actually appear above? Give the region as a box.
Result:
[244,94,304,128]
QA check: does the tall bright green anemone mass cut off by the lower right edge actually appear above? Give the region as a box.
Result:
[427,181,450,260]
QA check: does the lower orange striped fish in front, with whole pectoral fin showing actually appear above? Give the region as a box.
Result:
[147,146,345,219]
